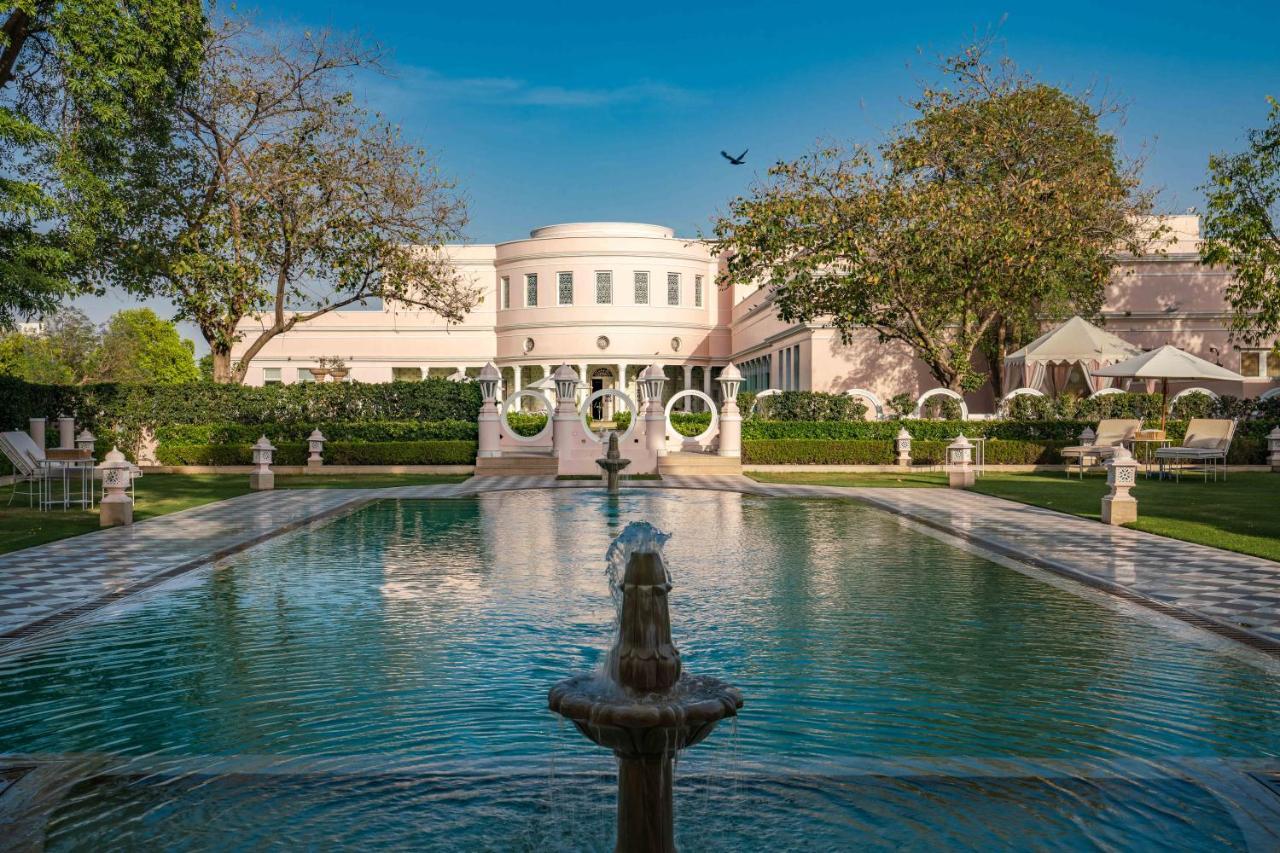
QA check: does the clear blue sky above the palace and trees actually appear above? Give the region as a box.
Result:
[82,0,1280,343]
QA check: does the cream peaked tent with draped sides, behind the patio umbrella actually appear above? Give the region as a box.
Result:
[1005,316,1142,393]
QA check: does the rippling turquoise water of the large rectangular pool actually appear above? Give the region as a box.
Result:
[0,489,1280,850]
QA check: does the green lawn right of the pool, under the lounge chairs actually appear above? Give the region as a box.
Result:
[751,471,1280,561]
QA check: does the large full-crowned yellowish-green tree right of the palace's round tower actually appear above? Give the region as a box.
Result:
[714,42,1160,391]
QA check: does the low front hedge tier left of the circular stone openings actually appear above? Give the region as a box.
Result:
[156,441,476,465]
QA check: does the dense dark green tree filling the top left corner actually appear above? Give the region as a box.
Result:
[0,0,205,328]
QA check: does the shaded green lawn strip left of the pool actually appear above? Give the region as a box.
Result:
[0,474,467,553]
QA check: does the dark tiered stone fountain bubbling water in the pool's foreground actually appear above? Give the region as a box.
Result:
[547,521,742,853]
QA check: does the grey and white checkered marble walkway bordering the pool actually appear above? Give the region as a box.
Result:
[0,476,1280,652]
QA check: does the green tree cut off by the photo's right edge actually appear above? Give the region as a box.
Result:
[1201,97,1280,346]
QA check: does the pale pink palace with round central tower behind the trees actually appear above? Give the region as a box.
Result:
[232,215,1280,415]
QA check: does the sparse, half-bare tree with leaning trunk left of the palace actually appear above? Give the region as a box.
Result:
[118,20,479,382]
